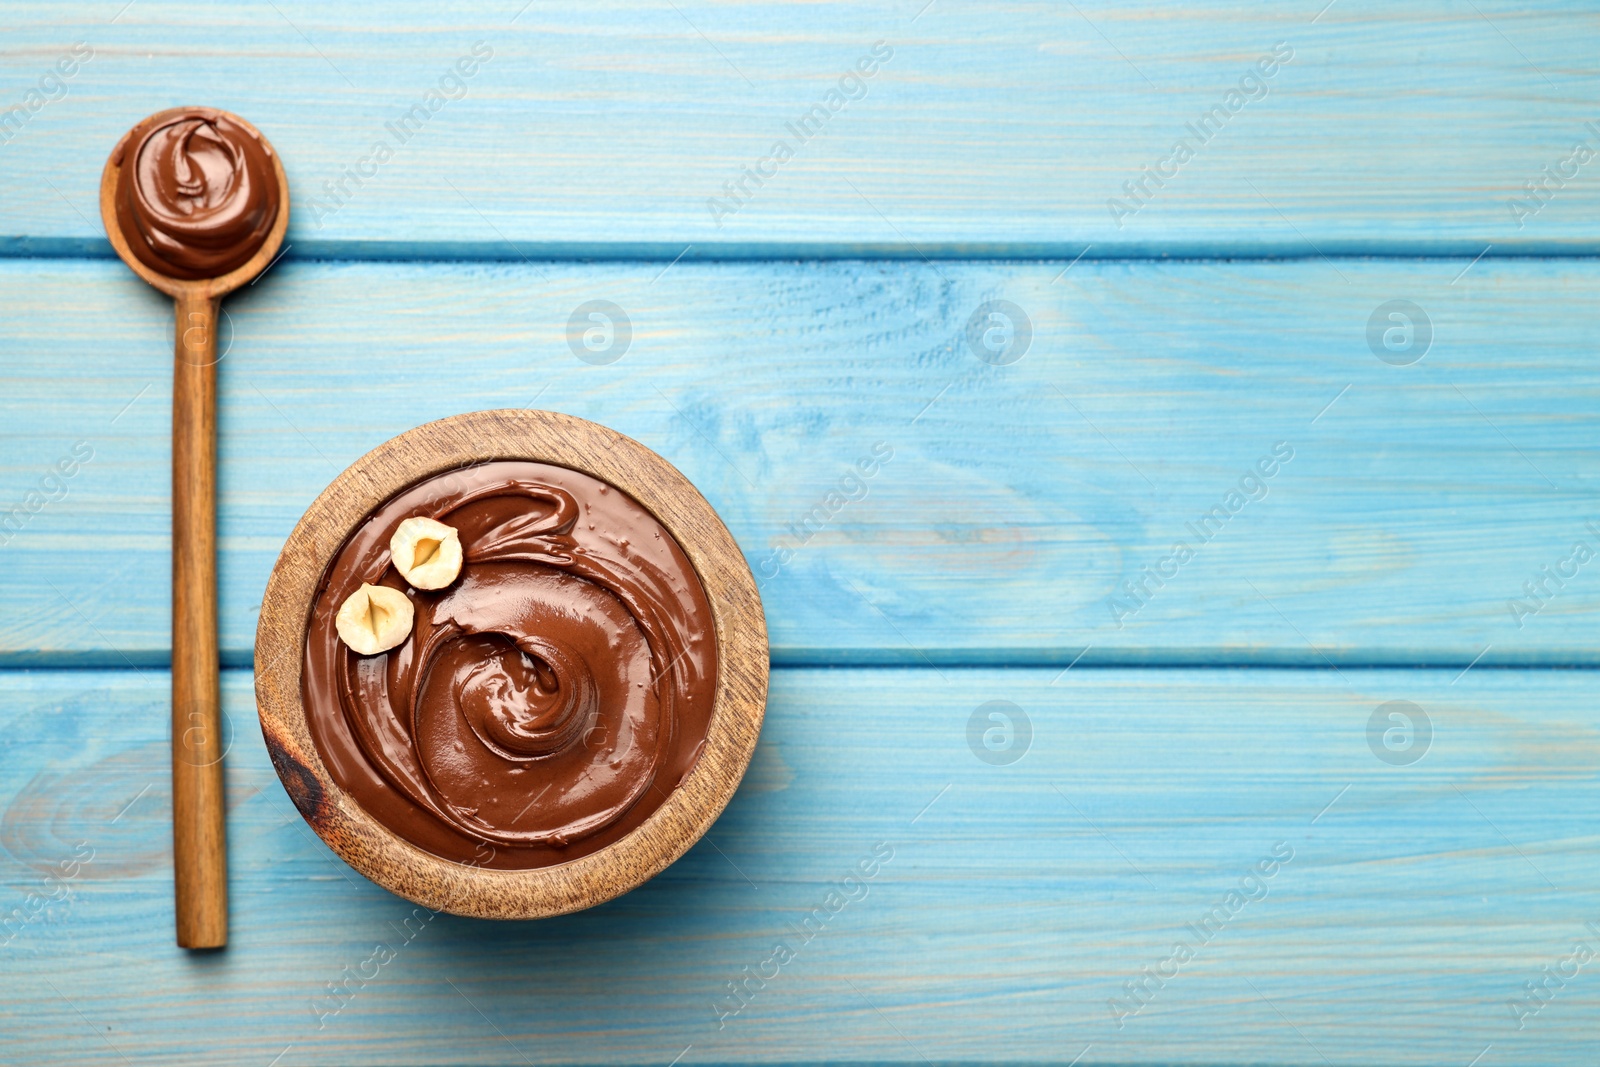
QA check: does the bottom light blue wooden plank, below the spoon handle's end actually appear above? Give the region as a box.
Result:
[0,667,1600,1067]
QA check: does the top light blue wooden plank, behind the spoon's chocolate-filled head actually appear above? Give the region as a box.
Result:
[0,0,1600,259]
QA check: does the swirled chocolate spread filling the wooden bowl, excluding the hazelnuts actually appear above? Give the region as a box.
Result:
[302,461,717,870]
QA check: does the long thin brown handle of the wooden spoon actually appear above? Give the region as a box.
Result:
[173,293,227,949]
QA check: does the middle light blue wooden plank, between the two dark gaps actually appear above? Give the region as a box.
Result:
[0,259,1600,669]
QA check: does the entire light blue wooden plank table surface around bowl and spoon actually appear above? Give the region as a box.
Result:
[0,0,1600,1067]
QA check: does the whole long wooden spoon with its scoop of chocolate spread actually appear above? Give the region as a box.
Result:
[101,107,290,949]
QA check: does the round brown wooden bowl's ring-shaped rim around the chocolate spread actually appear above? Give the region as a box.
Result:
[256,410,768,918]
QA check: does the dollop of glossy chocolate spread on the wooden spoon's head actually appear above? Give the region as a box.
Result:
[112,107,282,280]
